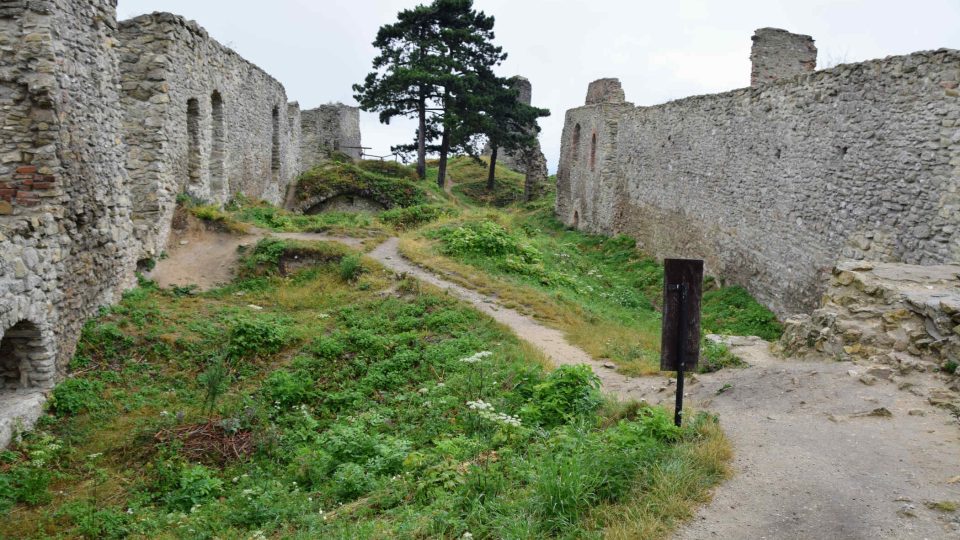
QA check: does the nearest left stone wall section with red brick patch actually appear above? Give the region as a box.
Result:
[0,0,134,398]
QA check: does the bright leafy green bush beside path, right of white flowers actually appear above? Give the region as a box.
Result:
[521,365,602,427]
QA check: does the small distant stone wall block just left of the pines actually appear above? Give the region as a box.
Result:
[300,103,363,170]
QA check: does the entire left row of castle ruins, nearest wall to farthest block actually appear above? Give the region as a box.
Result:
[0,0,360,446]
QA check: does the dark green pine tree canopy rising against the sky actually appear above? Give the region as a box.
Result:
[353,0,549,187]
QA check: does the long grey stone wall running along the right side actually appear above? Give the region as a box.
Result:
[556,50,960,315]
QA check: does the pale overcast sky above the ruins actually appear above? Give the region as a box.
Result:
[118,0,960,171]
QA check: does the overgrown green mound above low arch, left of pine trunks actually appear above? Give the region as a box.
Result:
[296,162,426,208]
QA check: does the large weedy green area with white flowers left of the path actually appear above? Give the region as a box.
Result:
[0,247,729,538]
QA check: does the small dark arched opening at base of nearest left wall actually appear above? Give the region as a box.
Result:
[0,321,46,392]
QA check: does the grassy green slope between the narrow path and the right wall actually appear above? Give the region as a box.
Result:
[401,202,782,374]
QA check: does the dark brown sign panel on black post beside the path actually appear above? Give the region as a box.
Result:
[660,259,703,427]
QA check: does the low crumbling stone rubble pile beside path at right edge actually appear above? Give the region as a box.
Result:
[779,261,960,390]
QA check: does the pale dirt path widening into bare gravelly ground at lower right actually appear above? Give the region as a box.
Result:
[370,238,960,540]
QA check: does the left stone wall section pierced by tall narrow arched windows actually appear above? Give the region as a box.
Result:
[120,13,299,256]
